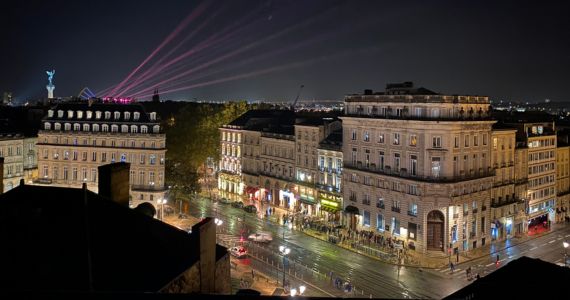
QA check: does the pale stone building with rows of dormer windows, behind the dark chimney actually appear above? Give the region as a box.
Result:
[36,103,166,207]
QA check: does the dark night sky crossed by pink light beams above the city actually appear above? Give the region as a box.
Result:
[0,0,570,102]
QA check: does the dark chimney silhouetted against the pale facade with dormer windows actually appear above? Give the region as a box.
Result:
[98,162,131,207]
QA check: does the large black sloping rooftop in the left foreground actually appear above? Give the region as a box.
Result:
[0,185,203,292]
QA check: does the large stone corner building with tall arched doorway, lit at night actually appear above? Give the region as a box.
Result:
[341,82,495,252]
